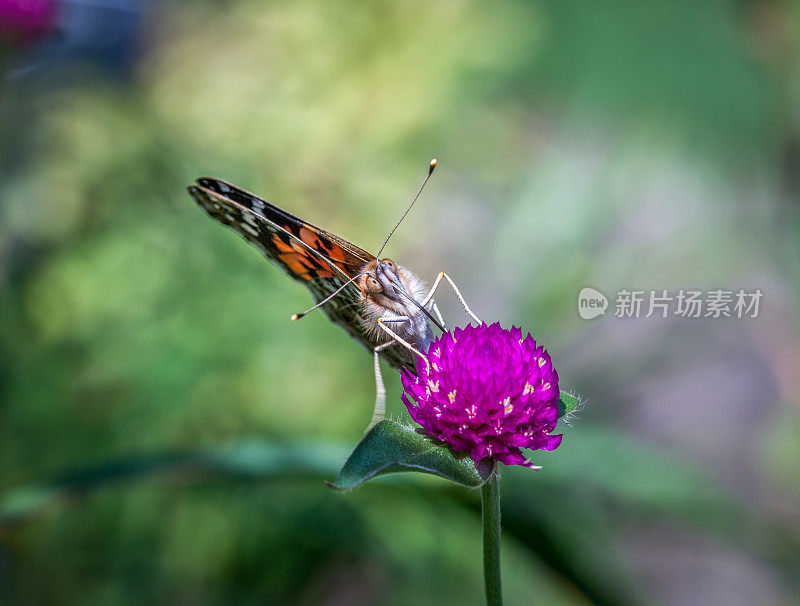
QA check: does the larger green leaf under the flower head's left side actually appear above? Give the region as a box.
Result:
[331,420,484,490]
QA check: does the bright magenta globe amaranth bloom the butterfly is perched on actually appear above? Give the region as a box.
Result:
[402,324,561,467]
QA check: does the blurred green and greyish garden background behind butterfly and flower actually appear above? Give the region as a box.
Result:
[0,0,800,606]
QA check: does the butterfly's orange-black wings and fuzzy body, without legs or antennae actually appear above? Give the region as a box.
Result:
[187,178,433,368]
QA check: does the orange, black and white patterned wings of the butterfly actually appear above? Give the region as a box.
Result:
[187,178,413,368]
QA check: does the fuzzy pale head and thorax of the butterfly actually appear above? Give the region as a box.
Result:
[358,259,433,351]
